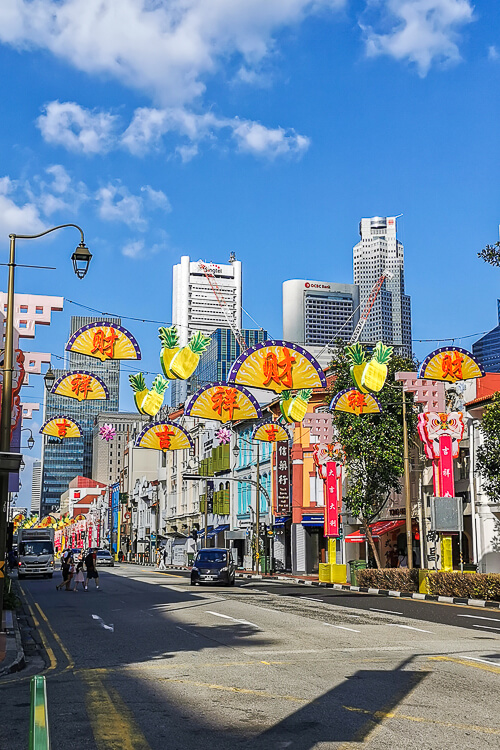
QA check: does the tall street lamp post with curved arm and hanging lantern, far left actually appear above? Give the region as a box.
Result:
[0,224,92,617]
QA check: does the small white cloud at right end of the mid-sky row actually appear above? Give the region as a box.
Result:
[233,121,310,159]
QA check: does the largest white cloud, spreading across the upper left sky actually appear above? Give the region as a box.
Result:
[0,0,345,106]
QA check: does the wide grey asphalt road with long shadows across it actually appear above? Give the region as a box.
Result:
[0,565,500,750]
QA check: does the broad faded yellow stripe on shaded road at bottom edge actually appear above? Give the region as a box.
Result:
[82,672,151,750]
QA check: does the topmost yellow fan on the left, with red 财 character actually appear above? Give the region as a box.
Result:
[66,320,141,362]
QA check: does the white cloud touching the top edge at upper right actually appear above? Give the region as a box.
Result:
[362,0,473,77]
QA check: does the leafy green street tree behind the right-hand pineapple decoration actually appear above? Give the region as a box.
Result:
[330,342,417,568]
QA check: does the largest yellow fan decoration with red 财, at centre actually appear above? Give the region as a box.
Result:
[227,341,326,393]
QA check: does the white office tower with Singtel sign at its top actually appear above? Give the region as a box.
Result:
[170,253,241,406]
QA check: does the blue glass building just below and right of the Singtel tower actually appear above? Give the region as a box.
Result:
[192,328,269,391]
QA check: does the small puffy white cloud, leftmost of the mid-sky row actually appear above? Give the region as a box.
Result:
[36,100,117,154]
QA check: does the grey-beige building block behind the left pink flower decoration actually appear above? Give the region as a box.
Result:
[92,411,149,484]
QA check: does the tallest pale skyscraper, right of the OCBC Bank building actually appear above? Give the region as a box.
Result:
[353,216,412,356]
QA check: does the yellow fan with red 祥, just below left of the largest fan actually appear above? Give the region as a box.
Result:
[184,382,262,424]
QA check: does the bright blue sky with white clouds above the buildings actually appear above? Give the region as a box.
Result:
[0,0,500,506]
